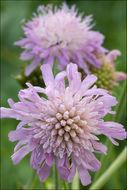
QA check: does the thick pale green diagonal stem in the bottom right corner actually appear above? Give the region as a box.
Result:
[90,147,127,190]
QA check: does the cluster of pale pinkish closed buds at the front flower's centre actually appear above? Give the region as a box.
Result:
[43,104,87,157]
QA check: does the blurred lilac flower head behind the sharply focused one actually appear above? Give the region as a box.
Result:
[15,3,107,76]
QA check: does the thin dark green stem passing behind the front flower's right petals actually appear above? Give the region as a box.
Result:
[94,82,126,181]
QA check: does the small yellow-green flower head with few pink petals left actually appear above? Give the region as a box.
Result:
[80,50,127,91]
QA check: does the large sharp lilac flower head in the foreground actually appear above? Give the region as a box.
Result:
[1,63,126,185]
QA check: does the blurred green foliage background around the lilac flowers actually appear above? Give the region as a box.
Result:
[1,0,127,190]
